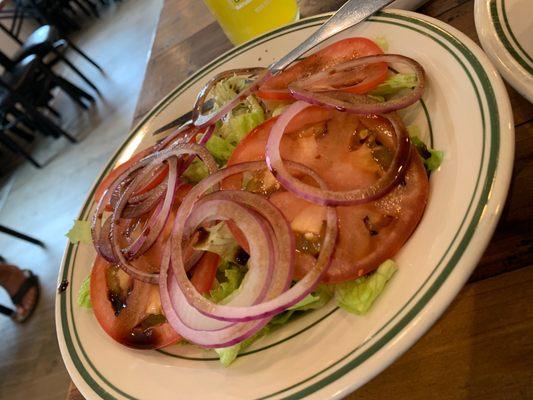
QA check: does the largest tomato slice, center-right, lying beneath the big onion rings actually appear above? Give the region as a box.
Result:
[223,108,429,283]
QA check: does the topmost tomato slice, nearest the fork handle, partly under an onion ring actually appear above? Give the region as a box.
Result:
[257,37,387,100]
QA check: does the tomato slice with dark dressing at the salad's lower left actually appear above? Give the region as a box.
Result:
[91,253,219,349]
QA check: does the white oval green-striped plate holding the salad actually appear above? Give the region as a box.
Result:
[56,10,514,399]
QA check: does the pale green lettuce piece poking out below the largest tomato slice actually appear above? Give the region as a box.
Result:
[334,260,398,315]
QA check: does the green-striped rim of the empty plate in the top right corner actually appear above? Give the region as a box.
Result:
[474,0,533,102]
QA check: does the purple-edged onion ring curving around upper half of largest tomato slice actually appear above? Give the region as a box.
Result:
[266,101,410,206]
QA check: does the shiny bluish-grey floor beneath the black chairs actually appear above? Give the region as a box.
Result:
[0,0,162,399]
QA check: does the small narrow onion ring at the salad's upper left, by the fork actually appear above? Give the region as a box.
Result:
[192,67,268,128]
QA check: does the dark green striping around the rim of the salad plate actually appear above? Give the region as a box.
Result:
[60,12,499,399]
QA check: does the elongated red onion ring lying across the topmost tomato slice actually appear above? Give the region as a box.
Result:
[289,54,426,114]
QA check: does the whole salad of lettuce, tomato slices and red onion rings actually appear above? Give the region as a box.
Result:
[68,37,442,365]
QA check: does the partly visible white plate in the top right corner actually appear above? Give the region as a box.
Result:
[474,0,533,102]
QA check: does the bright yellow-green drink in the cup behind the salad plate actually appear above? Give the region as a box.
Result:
[204,0,299,45]
